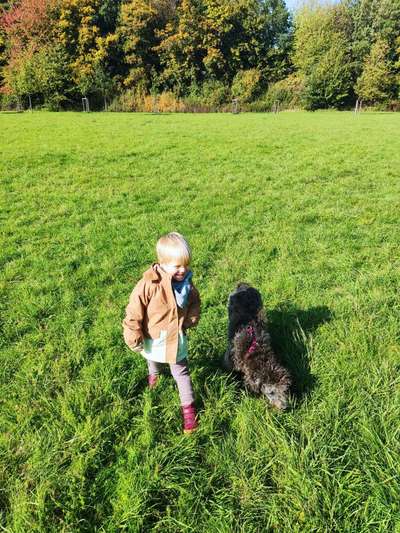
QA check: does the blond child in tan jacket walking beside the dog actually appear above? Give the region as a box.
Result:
[122,232,200,433]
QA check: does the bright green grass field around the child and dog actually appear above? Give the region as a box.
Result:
[0,112,400,533]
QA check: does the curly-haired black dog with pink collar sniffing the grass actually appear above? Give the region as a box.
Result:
[224,283,292,410]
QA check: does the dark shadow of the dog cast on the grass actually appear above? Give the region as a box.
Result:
[266,302,333,401]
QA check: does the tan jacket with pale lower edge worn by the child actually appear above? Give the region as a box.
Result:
[122,264,200,363]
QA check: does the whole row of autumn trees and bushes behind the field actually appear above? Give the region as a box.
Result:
[0,0,400,110]
